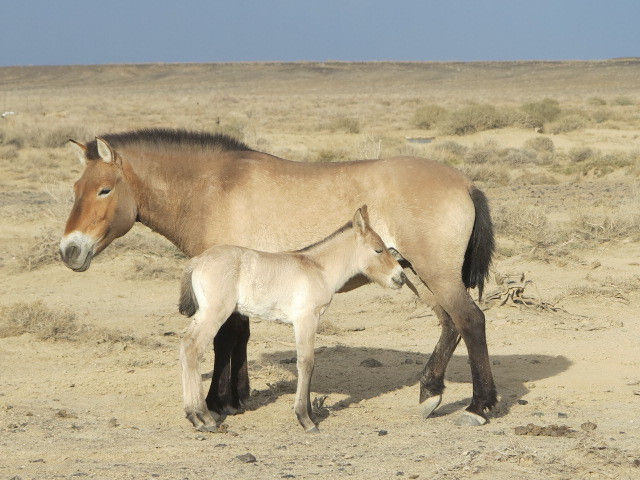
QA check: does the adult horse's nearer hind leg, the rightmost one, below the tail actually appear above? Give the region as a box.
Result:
[429,282,497,425]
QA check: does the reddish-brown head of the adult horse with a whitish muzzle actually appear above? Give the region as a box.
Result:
[60,138,138,272]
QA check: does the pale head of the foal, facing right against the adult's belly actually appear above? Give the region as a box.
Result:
[353,205,407,288]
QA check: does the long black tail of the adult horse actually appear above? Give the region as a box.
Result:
[462,185,495,299]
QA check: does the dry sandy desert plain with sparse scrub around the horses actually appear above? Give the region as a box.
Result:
[0,59,640,480]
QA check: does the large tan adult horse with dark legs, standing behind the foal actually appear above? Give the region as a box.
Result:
[60,129,496,425]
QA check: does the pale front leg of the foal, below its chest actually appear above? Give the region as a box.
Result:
[294,316,319,433]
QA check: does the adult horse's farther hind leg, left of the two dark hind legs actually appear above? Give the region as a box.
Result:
[420,305,460,418]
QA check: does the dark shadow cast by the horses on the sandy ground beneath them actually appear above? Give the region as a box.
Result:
[232,346,571,424]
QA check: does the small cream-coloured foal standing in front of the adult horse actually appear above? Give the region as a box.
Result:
[180,205,406,432]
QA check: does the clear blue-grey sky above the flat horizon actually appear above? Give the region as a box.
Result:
[0,0,640,66]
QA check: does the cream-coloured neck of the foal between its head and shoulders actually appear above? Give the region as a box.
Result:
[306,229,359,293]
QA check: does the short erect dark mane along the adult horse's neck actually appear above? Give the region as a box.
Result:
[87,128,251,160]
